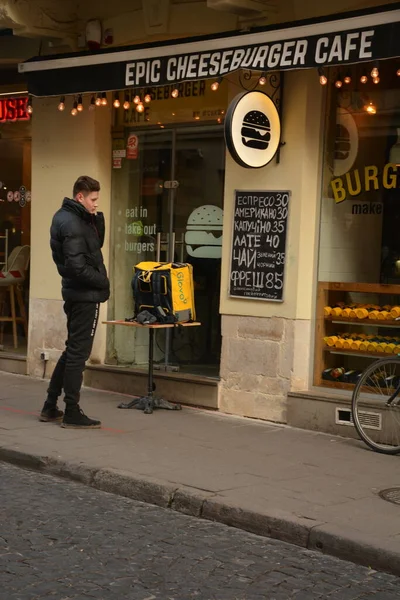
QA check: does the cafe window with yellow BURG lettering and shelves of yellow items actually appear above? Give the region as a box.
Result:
[314,60,400,390]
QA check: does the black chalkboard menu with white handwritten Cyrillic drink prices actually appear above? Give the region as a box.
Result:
[229,190,290,302]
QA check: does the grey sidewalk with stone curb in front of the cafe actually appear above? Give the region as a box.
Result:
[0,373,400,575]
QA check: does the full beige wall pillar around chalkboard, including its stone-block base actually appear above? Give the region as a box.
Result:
[220,71,325,422]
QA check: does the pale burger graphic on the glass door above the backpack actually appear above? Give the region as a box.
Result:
[185,204,224,258]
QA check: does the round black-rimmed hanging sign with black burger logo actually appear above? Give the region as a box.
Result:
[225,92,281,169]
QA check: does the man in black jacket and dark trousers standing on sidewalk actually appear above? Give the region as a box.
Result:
[40,176,110,429]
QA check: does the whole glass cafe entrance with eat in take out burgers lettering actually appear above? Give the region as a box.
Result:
[109,126,225,377]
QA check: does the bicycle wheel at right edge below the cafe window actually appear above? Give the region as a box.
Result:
[351,358,400,454]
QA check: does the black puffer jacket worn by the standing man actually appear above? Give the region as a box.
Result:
[50,198,110,302]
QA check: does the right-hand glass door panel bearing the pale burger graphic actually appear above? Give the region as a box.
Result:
[160,127,225,376]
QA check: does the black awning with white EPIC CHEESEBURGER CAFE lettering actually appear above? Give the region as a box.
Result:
[19,4,400,96]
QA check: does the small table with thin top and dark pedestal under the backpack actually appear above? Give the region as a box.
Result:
[103,321,201,415]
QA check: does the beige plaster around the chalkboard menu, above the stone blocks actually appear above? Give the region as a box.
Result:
[220,70,323,319]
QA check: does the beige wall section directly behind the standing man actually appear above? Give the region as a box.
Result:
[28,98,111,375]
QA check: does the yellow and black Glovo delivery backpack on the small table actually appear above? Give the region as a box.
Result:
[132,262,196,323]
